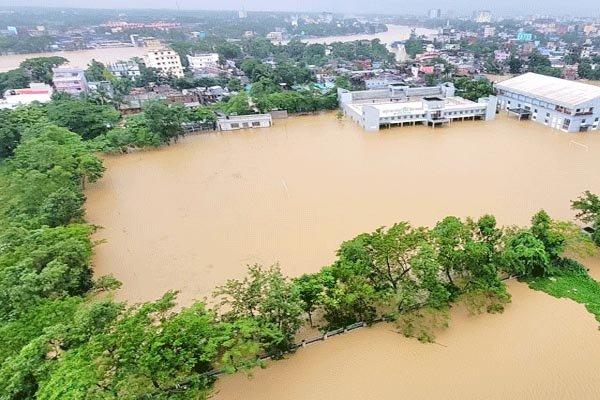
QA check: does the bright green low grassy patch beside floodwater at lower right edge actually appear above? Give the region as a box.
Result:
[527,268,600,322]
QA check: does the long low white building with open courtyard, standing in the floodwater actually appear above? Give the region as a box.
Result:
[338,83,497,131]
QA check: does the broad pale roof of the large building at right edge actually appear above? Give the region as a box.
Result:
[496,72,600,107]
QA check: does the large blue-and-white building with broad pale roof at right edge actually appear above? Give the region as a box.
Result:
[496,72,600,132]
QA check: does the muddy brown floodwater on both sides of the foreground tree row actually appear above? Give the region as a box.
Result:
[87,114,600,400]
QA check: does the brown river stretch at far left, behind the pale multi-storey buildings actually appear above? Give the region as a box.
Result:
[0,47,148,72]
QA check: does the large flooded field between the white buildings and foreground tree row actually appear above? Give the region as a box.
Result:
[86,114,600,304]
